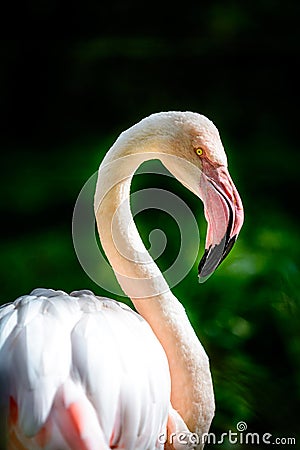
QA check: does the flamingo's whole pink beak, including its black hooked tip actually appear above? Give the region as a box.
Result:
[198,160,244,283]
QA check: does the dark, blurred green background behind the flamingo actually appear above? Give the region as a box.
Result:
[0,0,300,448]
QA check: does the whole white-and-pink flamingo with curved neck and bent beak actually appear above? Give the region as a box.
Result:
[0,111,244,450]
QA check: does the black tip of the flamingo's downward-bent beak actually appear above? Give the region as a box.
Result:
[198,235,237,283]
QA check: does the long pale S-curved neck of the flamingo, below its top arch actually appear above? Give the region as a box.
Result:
[95,133,214,433]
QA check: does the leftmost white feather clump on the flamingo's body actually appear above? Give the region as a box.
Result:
[0,295,77,436]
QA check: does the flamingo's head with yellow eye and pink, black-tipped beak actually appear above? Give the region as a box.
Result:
[157,112,244,282]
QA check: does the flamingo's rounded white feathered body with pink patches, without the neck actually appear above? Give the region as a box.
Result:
[0,289,170,450]
